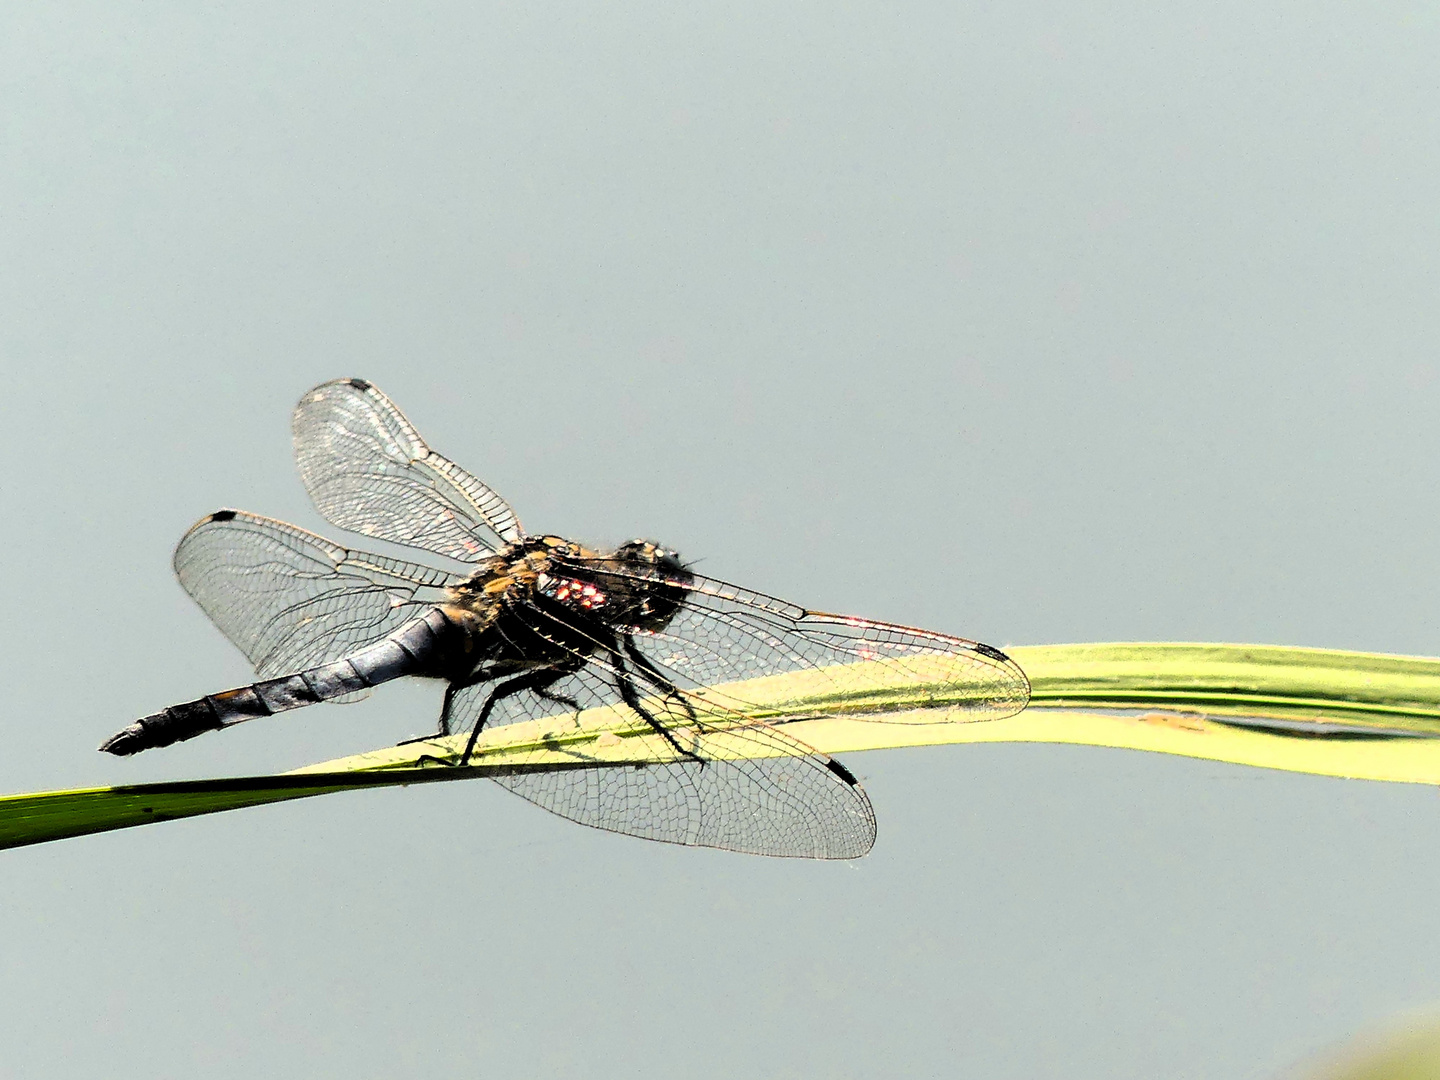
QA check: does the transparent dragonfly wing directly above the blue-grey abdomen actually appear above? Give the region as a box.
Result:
[174,510,456,678]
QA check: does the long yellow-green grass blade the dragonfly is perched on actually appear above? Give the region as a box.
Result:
[11,642,1440,847]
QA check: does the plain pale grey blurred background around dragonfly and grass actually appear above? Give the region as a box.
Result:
[0,3,1440,1080]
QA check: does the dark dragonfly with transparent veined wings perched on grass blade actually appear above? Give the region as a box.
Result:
[99,379,1030,858]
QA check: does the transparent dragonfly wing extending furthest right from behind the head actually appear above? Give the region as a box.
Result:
[544,560,1030,723]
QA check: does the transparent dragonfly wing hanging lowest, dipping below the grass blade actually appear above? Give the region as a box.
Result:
[455,622,876,858]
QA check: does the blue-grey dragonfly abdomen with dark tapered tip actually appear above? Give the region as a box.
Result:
[99,608,471,756]
